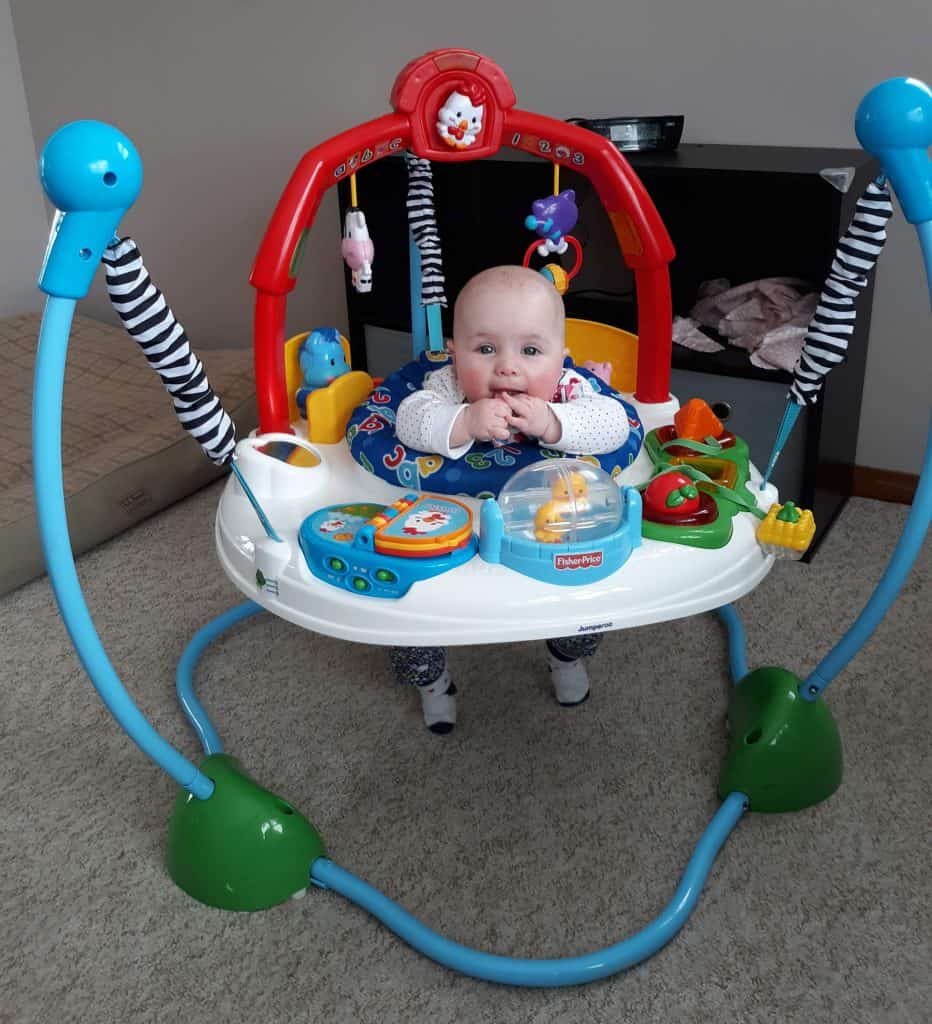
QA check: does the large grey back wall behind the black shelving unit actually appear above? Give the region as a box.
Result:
[7,0,932,472]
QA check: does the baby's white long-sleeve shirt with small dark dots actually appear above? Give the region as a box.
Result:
[395,365,630,459]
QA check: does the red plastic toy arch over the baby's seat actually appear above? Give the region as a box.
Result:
[250,49,675,433]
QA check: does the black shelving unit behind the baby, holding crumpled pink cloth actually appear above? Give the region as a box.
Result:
[340,143,879,557]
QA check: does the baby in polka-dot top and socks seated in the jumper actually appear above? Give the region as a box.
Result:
[391,266,629,734]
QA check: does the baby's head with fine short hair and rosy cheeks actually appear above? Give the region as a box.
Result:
[450,266,566,401]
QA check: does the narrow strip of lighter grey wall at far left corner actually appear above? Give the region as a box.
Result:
[0,0,48,316]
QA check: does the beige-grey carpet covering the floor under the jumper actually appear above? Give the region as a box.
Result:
[0,485,932,1024]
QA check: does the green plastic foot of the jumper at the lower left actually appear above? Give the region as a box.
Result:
[167,754,325,910]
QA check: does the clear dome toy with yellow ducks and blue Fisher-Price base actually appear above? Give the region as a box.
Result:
[479,459,641,586]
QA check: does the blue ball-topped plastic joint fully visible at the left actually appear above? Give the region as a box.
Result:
[39,121,142,299]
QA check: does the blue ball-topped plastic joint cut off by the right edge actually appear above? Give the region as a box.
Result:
[854,78,932,224]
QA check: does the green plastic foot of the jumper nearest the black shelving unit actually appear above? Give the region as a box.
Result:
[718,668,842,812]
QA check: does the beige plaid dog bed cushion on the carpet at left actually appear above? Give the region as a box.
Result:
[0,313,257,594]
